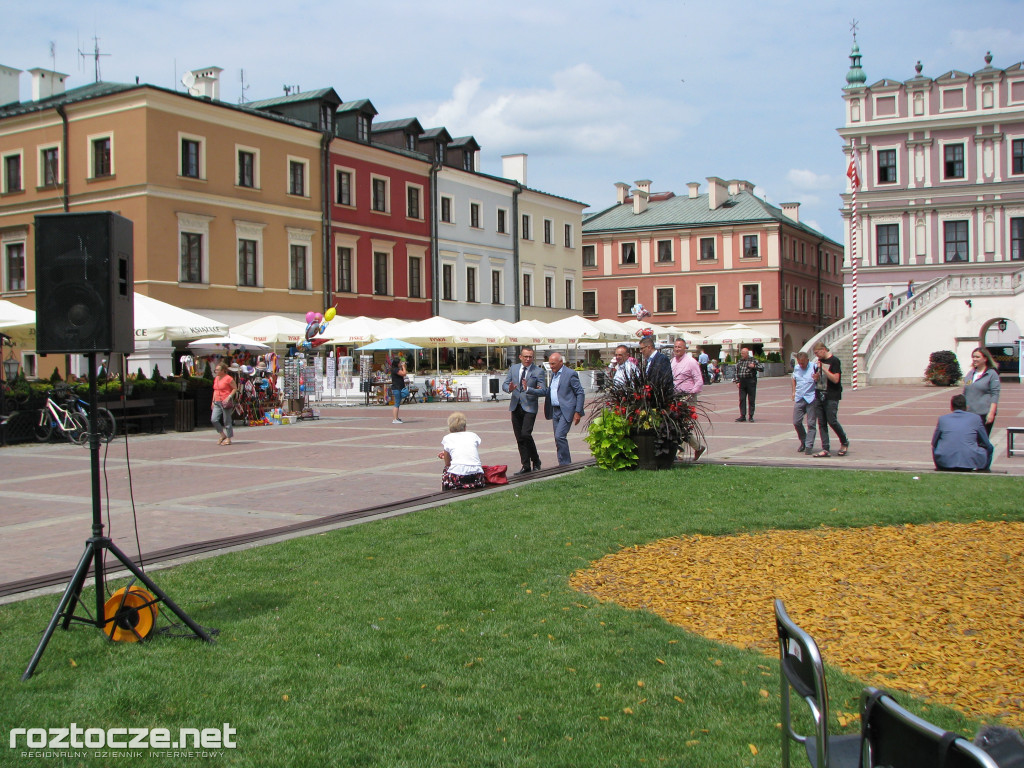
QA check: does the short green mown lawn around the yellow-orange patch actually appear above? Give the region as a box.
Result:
[0,465,1024,768]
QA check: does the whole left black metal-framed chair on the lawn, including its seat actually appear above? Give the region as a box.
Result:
[775,600,860,768]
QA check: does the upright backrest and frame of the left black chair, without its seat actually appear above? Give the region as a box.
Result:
[775,600,828,768]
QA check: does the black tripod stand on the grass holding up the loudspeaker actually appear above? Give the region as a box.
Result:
[22,352,213,680]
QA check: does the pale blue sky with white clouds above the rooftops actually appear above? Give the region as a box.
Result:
[6,0,1024,243]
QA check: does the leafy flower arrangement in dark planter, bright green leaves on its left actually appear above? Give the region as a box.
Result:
[585,362,708,469]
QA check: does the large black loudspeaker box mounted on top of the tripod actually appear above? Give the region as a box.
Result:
[36,211,135,354]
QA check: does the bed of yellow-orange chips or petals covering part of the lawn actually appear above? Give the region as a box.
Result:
[571,522,1024,727]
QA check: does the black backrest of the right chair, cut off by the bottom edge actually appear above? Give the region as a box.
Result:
[860,688,998,768]
